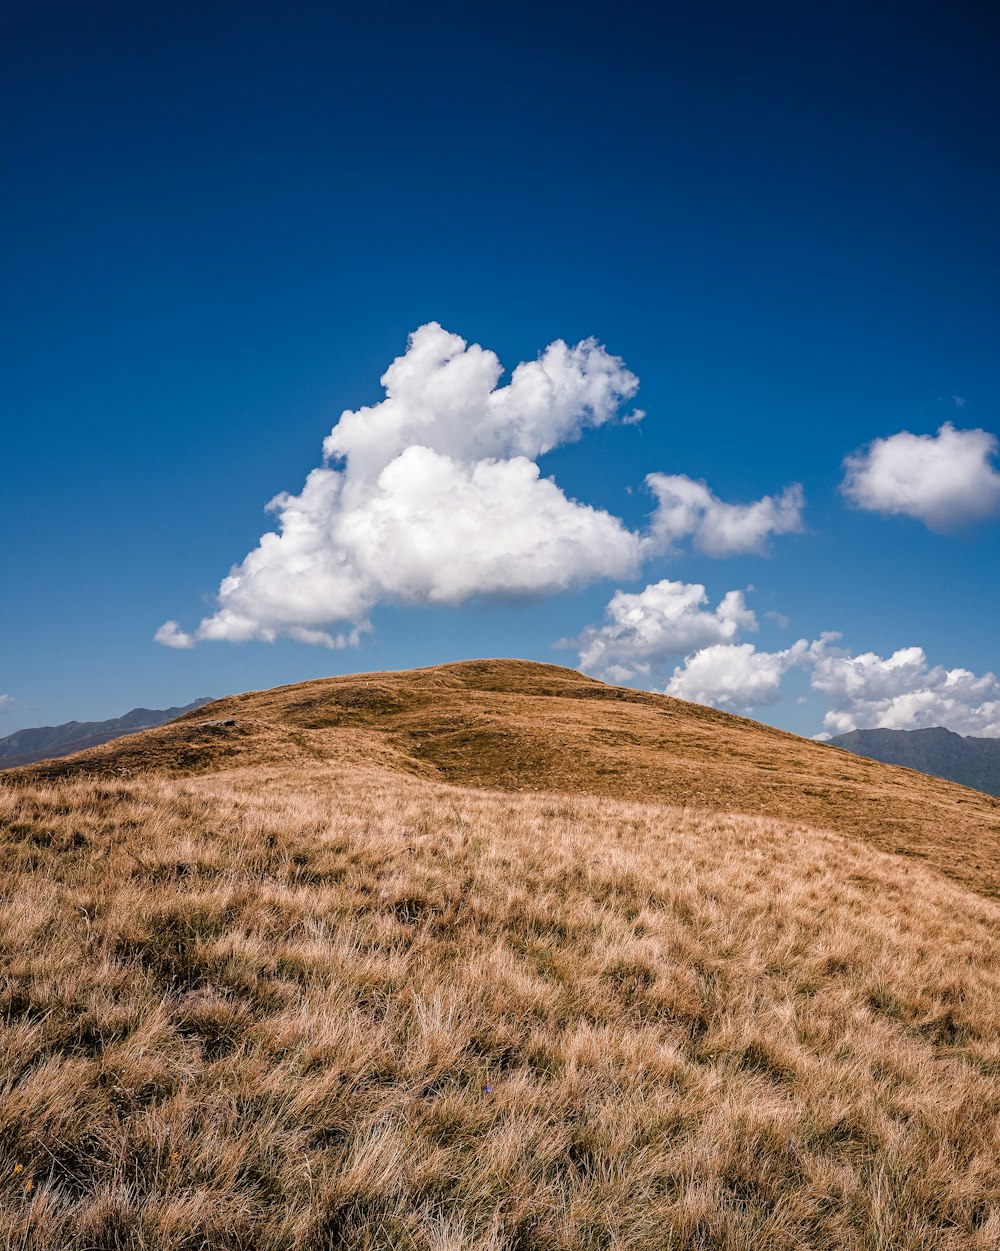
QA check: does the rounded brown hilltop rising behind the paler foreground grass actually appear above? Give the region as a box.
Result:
[13,661,1000,894]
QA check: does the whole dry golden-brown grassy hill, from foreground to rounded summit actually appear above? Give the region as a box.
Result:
[0,662,1000,1251]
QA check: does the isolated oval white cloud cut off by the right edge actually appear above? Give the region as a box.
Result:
[841,422,1000,532]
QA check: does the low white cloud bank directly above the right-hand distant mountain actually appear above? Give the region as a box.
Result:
[811,636,1000,738]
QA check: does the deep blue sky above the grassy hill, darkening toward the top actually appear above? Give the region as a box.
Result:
[0,0,1000,734]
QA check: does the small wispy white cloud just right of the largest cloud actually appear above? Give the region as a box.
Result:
[646,473,805,557]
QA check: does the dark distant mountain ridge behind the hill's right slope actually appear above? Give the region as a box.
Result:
[830,726,1000,796]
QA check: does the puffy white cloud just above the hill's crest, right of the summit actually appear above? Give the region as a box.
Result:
[578,579,757,682]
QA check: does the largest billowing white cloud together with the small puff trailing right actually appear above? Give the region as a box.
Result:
[155,322,802,648]
